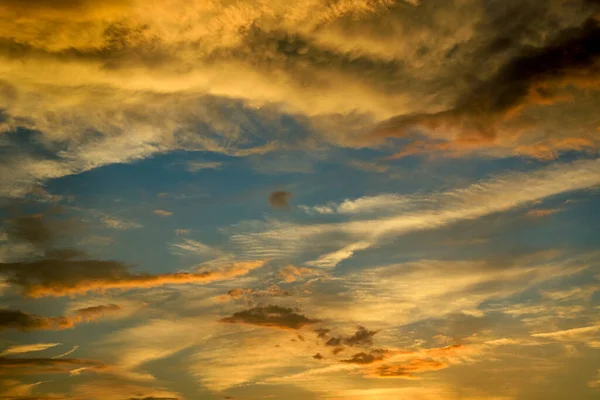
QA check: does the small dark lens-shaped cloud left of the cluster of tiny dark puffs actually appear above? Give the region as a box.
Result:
[220,305,319,329]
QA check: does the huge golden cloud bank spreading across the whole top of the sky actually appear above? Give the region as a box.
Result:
[0,0,597,197]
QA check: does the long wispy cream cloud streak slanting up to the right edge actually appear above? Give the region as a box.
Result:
[231,159,600,265]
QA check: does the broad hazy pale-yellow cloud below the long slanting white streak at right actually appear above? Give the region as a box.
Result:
[311,252,596,326]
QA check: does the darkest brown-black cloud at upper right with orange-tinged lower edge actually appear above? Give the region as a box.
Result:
[375,11,600,156]
